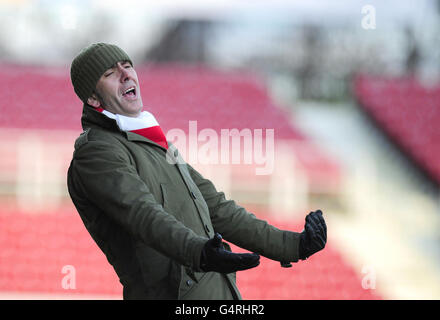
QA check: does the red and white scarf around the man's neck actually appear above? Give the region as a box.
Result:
[95,108,168,149]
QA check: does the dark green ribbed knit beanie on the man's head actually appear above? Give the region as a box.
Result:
[70,43,133,103]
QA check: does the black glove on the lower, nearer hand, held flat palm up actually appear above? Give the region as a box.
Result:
[200,233,260,273]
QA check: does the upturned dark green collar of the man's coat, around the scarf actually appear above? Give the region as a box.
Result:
[81,104,167,151]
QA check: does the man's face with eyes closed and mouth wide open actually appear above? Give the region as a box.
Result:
[89,62,143,117]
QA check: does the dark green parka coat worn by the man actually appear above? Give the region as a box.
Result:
[67,106,299,299]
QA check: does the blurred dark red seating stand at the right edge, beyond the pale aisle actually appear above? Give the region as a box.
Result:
[354,75,440,184]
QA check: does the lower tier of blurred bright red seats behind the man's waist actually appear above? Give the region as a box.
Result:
[0,207,380,300]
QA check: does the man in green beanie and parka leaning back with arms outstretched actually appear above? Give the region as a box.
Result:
[68,43,327,299]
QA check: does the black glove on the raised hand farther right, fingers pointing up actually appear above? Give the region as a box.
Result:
[299,210,327,260]
